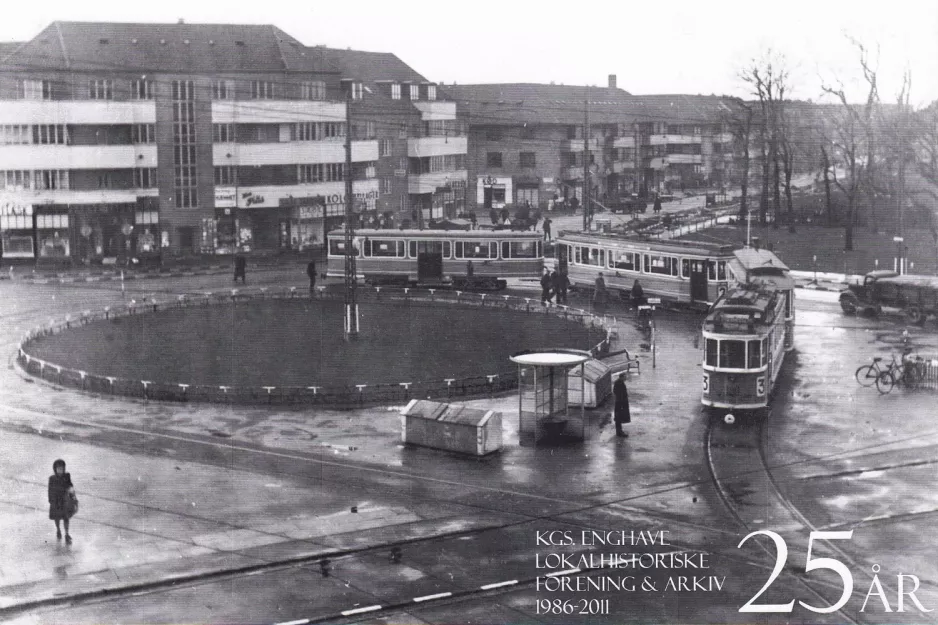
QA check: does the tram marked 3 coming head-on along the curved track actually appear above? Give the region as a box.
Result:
[701,248,795,411]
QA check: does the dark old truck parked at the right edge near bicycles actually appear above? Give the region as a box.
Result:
[840,270,938,325]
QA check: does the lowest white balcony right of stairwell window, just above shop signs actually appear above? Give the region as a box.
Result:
[215,179,378,208]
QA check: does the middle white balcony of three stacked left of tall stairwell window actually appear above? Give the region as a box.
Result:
[0,144,156,170]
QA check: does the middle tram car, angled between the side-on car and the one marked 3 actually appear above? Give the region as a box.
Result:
[556,232,737,308]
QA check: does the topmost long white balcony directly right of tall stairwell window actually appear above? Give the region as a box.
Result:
[212,100,346,124]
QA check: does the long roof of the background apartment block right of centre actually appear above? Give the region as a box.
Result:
[447,83,728,125]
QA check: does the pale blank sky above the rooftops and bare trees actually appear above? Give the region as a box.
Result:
[0,0,938,106]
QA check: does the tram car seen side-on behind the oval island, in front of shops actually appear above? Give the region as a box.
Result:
[326,229,544,290]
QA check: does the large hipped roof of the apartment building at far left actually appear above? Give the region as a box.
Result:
[2,22,336,73]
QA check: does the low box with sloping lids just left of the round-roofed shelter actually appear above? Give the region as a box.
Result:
[401,399,502,456]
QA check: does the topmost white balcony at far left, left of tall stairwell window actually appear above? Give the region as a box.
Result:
[0,100,156,125]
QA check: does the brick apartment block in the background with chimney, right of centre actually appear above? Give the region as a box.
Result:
[448,81,732,211]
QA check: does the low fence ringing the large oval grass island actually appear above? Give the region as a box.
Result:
[16,286,616,408]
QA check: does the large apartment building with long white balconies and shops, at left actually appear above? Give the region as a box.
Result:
[0,22,466,263]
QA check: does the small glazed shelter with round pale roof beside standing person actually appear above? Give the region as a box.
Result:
[511,348,592,445]
